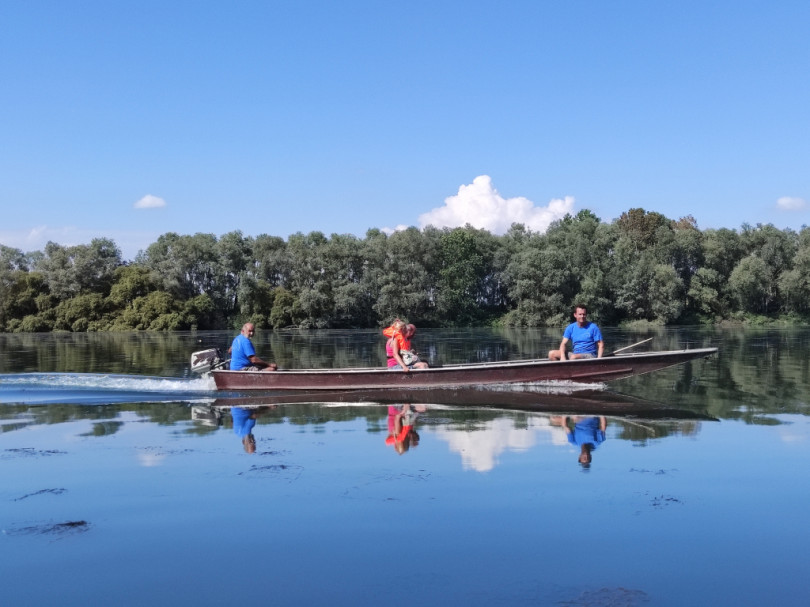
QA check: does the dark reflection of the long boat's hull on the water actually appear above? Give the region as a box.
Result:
[205,388,715,420]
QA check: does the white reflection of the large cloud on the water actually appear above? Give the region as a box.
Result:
[436,417,568,472]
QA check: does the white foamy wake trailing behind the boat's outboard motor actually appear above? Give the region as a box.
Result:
[0,373,216,405]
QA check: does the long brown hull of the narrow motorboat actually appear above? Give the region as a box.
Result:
[211,348,717,391]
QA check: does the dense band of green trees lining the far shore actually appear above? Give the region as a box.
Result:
[0,209,810,332]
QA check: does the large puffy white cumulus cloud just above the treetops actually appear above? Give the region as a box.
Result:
[419,175,574,234]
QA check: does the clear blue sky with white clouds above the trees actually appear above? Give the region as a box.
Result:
[0,0,810,259]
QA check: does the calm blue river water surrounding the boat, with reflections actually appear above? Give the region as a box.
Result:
[0,328,810,606]
